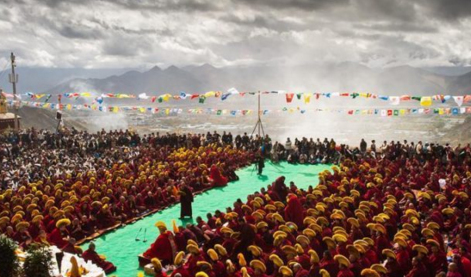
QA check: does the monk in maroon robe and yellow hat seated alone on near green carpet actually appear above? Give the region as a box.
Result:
[143,221,177,265]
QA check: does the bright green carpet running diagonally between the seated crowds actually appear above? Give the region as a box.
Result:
[82,162,330,277]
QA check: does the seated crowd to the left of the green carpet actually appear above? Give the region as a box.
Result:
[0,130,253,269]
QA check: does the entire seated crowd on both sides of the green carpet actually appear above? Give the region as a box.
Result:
[0,126,471,277]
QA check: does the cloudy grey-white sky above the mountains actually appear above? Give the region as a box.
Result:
[0,0,471,68]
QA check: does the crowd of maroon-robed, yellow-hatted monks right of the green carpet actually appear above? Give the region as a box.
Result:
[144,142,471,277]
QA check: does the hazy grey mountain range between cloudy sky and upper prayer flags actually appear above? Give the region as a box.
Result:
[3,62,471,95]
